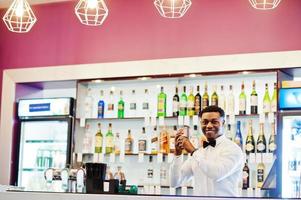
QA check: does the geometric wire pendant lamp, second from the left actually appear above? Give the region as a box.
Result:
[75,0,109,26]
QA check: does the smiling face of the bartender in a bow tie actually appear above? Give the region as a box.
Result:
[201,112,224,140]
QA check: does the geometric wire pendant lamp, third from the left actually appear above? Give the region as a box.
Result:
[154,0,191,18]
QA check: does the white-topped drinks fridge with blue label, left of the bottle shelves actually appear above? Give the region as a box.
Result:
[16,98,74,191]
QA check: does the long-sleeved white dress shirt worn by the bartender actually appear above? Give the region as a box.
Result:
[170,135,244,196]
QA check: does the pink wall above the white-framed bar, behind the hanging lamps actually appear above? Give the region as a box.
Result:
[0,0,301,71]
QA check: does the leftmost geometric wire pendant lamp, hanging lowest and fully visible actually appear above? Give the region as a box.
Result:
[3,0,37,33]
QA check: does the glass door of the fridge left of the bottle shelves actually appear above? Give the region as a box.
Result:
[18,120,68,191]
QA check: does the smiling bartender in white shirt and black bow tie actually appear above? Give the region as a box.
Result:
[170,106,244,196]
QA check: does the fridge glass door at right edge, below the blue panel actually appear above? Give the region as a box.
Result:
[282,116,301,198]
